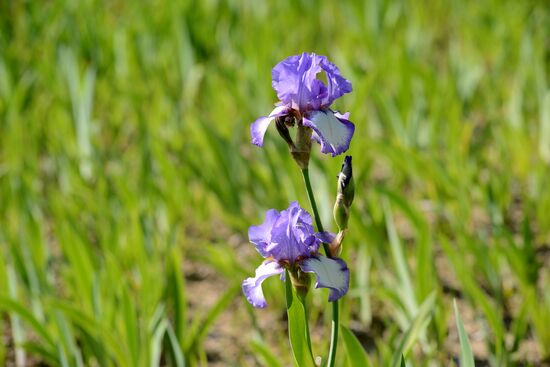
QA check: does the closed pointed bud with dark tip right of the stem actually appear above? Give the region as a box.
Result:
[333,155,355,231]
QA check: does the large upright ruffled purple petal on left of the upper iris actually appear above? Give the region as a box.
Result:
[271,52,328,112]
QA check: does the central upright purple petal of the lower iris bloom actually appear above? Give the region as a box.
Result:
[265,201,319,263]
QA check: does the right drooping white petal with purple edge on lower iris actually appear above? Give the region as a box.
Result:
[300,255,349,302]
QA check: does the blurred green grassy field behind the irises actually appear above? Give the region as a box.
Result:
[0,0,550,366]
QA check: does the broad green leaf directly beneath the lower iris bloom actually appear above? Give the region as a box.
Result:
[285,271,315,367]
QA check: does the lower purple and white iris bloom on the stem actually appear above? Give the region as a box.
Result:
[243,202,349,308]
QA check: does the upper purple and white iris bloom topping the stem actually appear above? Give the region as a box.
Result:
[250,52,355,157]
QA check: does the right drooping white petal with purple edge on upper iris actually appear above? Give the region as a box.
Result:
[303,110,355,157]
